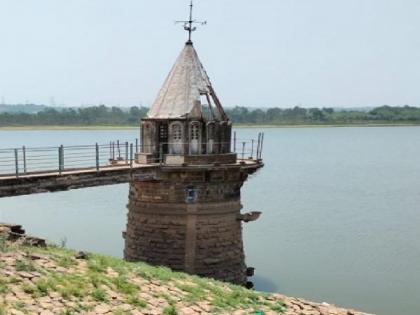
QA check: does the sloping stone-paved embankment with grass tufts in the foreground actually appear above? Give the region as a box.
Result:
[0,225,374,315]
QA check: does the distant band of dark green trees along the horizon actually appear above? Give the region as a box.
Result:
[0,105,420,127]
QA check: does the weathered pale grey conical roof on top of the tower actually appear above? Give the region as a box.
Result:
[147,42,223,119]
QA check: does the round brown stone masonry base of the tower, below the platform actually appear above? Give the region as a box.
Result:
[124,166,246,284]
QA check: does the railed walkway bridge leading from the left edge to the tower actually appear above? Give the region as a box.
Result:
[0,133,263,198]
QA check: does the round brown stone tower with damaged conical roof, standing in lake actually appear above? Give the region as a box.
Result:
[124,7,263,284]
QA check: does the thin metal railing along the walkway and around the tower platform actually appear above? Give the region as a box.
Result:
[0,132,264,178]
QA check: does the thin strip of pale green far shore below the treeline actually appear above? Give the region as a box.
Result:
[0,123,420,131]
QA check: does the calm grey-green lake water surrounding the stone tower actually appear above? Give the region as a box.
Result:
[0,127,420,315]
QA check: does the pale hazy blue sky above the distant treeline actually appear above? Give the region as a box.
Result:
[0,0,420,107]
